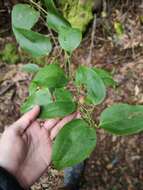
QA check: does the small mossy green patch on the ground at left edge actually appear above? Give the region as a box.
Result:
[0,43,20,64]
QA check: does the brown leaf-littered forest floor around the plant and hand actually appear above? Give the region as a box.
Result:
[0,2,143,190]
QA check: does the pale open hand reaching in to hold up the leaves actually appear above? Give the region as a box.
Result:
[0,106,77,189]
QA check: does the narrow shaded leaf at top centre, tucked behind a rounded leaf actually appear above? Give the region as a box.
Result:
[44,0,70,32]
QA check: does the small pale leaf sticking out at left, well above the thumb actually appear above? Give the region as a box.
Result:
[22,63,40,73]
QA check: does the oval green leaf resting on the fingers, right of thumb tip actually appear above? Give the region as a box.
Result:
[39,101,76,119]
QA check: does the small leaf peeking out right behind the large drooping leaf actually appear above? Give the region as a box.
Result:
[93,68,117,87]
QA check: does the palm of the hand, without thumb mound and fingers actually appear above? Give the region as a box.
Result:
[18,122,52,188]
